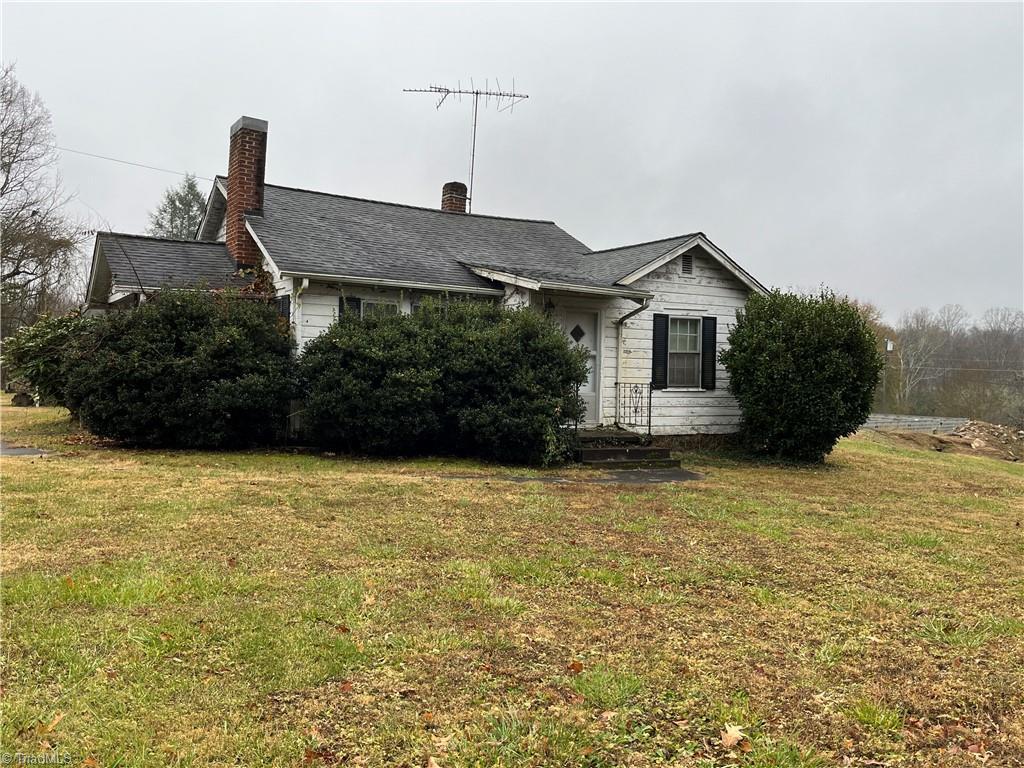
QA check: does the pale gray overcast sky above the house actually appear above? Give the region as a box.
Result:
[2,2,1024,318]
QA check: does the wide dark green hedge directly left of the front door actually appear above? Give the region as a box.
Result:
[300,301,587,464]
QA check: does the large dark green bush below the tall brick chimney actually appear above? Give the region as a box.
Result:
[66,291,295,447]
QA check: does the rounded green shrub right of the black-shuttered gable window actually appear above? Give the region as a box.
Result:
[720,291,882,461]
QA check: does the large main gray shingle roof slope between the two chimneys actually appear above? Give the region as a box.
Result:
[248,184,589,289]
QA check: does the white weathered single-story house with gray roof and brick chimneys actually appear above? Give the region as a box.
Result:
[89,118,764,434]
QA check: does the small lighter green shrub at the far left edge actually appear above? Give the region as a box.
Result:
[3,312,95,406]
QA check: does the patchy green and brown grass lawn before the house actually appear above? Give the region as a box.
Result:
[0,408,1024,768]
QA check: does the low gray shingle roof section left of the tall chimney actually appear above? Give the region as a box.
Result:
[96,232,249,288]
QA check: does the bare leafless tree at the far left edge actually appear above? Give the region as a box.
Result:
[0,65,86,336]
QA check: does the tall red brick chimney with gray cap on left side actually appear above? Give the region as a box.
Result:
[224,117,267,269]
